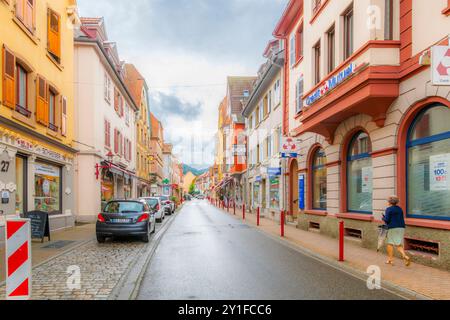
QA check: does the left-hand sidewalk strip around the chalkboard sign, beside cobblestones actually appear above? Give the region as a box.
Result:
[0,224,95,285]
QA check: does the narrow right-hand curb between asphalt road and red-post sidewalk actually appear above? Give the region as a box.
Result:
[214,206,434,300]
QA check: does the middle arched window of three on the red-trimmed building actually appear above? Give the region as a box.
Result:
[347,131,372,214]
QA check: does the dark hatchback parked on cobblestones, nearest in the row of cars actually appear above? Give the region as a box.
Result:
[96,200,156,243]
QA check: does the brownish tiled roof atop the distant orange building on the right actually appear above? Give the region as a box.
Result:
[227,77,256,115]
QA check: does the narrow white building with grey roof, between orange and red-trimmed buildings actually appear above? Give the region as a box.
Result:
[242,40,284,219]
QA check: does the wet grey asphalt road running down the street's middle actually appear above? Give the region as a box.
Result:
[138,200,399,300]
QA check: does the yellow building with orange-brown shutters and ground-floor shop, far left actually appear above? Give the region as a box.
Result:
[0,0,78,229]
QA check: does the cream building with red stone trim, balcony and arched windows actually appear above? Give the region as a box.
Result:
[274,0,450,268]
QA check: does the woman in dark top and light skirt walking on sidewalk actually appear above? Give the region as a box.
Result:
[383,196,411,267]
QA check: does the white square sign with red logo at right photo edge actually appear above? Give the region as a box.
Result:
[431,46,450,86]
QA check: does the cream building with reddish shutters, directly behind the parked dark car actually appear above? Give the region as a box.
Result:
[72,18,139,222]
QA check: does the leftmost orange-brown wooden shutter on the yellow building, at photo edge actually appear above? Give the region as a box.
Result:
[3,46,16,109]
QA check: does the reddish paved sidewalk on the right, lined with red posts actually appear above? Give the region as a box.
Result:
[220,205,450,300]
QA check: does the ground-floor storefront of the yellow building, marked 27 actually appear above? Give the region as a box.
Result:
[0,127,76,230]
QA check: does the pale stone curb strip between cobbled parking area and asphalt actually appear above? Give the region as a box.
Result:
[108,207,182,300]
